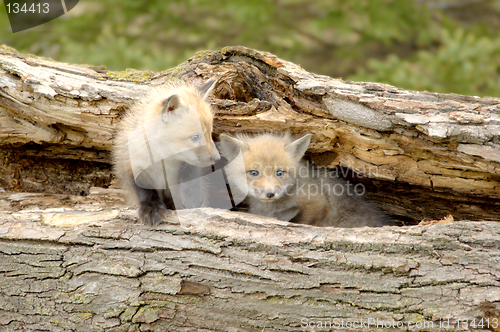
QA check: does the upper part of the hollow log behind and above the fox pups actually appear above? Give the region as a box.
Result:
[0,46,500,222]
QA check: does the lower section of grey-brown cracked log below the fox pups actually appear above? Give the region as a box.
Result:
[0,193,500,332]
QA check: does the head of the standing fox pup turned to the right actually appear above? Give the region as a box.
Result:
[140,80,220,167]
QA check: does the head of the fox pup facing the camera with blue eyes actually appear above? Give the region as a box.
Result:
[220,133,312,202]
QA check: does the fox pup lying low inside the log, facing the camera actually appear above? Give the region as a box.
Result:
[220,133,392,227]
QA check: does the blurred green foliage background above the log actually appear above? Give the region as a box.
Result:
[0,0,500,97]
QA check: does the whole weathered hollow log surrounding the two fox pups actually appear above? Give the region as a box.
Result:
[0,46,500,331]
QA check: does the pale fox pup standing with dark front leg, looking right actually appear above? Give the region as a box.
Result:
[113,80,220,225]
